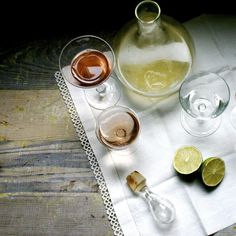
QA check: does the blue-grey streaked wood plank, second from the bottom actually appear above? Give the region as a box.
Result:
[0,138,98,193]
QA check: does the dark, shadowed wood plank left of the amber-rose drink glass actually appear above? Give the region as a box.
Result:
[0,39,63,90]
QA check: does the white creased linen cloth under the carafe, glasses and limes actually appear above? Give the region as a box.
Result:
[62,15,236,236]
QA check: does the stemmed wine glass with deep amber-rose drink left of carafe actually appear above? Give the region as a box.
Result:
[59,35,120,109]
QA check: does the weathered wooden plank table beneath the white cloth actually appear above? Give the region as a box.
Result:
[0,37,236,236]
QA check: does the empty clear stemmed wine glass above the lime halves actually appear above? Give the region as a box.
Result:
[179,72,230,137]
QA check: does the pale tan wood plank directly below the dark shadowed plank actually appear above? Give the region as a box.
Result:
[0,90,77,141]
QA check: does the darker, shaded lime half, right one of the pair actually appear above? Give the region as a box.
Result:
[201,157,225,187]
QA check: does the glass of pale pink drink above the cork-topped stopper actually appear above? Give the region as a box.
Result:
[96,106,140,150]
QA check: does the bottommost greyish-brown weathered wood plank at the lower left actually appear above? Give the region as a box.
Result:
[0,193,113,236]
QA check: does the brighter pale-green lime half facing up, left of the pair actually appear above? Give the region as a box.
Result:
[173,146,202,175]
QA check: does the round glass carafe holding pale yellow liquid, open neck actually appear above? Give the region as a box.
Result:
[114,0,194,97]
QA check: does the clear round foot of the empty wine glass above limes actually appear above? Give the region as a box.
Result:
[181,112,221,137]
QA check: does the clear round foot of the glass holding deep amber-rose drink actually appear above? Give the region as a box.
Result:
[84,77,121,110]
